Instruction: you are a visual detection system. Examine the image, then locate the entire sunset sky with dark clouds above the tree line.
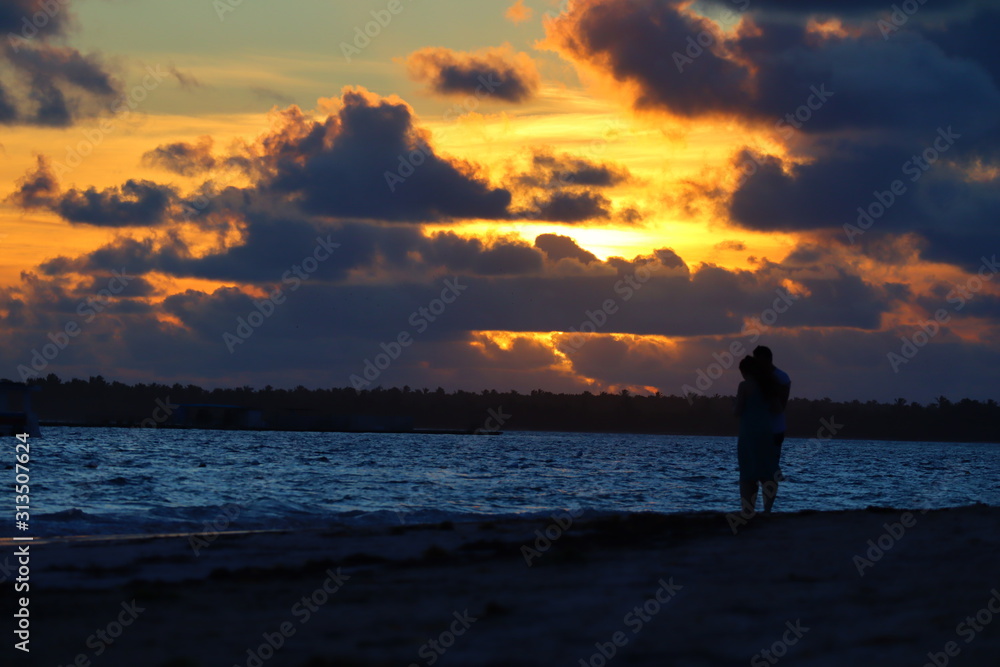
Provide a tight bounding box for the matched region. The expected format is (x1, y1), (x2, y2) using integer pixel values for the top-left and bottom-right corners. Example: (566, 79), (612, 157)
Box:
(0, 0), (1000, 402)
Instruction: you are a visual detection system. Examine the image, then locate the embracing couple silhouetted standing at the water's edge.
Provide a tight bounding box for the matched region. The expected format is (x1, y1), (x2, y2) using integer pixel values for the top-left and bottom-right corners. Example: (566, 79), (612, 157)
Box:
(735, 345), (792, 517)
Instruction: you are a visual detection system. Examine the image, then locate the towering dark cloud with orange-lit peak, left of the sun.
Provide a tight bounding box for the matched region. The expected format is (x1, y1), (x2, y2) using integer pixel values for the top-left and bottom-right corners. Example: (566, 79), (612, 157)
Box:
(28, 90), (511, 237)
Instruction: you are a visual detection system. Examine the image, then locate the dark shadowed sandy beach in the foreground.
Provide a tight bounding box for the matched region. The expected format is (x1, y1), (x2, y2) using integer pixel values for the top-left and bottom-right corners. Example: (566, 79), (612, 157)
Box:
(7, 506), (1000, 667)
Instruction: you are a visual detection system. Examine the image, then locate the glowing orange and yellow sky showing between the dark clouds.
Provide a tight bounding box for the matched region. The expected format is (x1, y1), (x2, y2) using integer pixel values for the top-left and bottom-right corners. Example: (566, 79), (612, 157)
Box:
(0, 0), (1000, 402)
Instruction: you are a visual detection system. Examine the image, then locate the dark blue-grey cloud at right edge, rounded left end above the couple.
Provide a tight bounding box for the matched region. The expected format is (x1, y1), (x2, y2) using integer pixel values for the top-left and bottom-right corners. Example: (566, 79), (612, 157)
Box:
(729, 137), (1000, 269)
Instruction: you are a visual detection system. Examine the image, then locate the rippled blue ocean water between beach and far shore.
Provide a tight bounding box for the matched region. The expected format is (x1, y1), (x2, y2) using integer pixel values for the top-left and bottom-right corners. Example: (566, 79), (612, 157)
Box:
(9, 427), (1000, 536)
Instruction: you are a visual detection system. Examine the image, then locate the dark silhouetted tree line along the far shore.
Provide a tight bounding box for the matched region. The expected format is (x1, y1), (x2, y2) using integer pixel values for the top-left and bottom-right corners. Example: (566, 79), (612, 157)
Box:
(9, 374), (1000, 442)
